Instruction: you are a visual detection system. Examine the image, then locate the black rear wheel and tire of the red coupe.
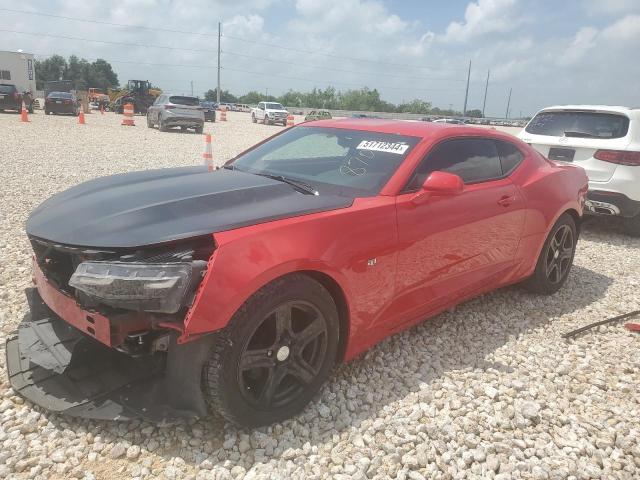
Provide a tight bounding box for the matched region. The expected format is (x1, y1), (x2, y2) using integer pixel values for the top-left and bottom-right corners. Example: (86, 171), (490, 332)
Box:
(524, 213), (578, 295)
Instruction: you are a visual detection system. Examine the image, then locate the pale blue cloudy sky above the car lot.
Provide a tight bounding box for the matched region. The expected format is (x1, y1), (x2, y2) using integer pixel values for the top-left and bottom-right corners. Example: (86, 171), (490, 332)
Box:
(0, 0), (640, 117)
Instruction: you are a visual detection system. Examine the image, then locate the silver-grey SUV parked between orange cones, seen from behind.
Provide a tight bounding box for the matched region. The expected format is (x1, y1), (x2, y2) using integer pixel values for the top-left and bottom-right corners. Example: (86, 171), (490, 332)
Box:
(147, 93), (204, 133)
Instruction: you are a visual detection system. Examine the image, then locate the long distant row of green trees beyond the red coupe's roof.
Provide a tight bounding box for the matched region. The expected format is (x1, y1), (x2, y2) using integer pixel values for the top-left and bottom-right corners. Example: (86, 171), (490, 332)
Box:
(205, 87), (482, 117)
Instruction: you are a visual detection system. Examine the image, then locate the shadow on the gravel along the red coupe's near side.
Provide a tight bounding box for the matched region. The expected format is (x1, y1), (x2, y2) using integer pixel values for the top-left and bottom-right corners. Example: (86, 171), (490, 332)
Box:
(38, 265), (613, 469)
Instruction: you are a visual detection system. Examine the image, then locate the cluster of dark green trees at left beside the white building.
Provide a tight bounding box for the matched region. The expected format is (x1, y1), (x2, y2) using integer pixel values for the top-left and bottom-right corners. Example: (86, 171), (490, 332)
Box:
(35, 55), (118, 91)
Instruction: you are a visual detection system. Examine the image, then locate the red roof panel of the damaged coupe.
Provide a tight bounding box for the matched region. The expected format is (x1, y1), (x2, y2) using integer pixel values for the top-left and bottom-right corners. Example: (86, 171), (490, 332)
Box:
(300, 117), (509, 138)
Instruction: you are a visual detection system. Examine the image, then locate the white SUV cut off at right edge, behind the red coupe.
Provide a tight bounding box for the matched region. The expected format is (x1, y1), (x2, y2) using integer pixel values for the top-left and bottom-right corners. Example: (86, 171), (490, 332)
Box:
(518, 105), (640, 236)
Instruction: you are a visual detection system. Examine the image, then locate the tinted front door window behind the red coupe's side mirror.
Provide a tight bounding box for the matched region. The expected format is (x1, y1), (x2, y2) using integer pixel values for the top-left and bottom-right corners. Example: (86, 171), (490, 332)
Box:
(404, 138), (502, 192)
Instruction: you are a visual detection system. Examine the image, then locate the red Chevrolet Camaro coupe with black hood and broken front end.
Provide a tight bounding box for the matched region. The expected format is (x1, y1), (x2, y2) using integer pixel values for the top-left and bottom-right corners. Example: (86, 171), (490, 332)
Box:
(6, 119), (587, 426)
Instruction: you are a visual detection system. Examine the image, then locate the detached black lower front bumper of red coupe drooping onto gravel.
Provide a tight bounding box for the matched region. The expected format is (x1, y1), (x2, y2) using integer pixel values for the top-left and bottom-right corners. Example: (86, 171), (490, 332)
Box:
(6, 288), (212, 424)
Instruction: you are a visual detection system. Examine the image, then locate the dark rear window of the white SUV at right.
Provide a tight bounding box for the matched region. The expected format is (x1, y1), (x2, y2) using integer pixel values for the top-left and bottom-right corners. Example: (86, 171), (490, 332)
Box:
(525, 111), (629, 138)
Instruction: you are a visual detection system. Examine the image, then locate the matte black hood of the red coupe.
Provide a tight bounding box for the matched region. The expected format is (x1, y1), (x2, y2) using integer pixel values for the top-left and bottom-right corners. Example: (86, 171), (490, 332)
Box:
(27, 167), (353, 248)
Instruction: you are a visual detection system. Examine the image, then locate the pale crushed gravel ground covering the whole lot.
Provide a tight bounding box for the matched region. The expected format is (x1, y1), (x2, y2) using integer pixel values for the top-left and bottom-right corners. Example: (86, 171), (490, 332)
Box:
(0, 112), (640, 480)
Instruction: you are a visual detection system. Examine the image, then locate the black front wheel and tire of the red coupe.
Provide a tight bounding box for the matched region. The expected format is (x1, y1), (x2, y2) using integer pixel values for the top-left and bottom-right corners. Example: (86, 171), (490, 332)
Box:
(202, 274), (340, 428)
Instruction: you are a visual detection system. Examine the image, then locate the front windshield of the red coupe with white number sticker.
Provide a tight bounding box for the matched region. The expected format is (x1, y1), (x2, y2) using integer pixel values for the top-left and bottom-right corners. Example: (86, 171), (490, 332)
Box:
(232, 127), (420, 197)
